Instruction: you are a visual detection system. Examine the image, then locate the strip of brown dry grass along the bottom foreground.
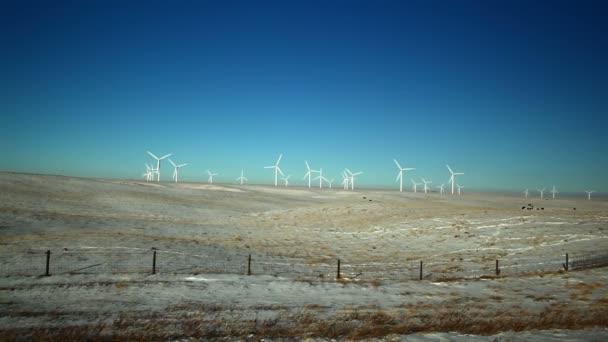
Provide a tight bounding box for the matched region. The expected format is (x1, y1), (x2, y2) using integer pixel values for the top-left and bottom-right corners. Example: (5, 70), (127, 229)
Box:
(2, 303), (608, 341)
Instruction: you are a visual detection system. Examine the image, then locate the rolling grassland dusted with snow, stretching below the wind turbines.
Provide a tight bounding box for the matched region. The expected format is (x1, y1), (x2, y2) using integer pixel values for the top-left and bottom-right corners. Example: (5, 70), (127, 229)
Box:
(0, 173), (608, 341)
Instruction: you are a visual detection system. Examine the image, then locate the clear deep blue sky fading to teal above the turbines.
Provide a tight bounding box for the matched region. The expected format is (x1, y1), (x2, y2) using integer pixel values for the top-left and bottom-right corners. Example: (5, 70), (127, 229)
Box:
(0, 0), (608, 192)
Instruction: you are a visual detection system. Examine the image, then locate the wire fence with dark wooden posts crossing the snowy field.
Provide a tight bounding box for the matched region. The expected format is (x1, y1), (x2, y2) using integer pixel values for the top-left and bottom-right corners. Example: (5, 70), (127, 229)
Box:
(0, 247), (608, 281)
